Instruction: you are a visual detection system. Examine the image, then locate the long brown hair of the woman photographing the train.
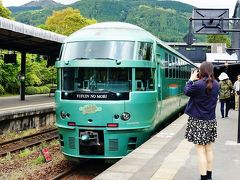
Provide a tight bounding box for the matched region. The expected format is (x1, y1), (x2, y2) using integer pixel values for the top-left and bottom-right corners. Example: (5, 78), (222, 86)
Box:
(199, 61), (215, 95)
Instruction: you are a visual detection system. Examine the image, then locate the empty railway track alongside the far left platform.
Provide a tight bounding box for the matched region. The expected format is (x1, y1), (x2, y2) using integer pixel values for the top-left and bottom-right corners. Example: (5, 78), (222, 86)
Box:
(0, 128), (58, 156)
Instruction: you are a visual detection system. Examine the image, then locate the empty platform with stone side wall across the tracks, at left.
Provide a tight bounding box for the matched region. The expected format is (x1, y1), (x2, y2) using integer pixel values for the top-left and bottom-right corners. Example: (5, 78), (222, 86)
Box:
(0, 94), (55, 135)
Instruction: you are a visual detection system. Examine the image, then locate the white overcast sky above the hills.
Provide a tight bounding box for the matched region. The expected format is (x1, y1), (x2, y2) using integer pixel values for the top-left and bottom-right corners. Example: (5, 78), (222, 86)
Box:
(3, 0), (237, 17)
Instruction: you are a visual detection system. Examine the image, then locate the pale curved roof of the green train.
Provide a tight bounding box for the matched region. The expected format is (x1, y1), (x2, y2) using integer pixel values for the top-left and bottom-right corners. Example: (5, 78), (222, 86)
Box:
(64, 22), (194, 65)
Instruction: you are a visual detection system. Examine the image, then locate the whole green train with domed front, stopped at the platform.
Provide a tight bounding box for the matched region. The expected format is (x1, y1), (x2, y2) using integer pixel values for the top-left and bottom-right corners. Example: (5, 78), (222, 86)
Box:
(55, 22), (196, 161)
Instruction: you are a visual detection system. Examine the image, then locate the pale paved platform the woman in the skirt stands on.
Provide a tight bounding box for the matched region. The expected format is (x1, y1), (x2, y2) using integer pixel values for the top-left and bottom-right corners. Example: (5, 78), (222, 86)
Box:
(94, 103), (240, 180)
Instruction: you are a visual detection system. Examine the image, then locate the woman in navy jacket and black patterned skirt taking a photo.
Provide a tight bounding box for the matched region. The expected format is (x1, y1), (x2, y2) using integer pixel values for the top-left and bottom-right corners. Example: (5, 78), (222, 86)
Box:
(184, 61), (219, 180)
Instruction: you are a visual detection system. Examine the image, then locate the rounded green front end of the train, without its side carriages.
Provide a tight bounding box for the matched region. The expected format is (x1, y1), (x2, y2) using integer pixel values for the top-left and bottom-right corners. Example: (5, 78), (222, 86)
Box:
(55, 23), (157, 160)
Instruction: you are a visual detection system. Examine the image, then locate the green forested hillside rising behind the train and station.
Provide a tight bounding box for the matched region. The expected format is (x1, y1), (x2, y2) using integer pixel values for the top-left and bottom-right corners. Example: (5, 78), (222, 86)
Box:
(9, 0), (203, 42)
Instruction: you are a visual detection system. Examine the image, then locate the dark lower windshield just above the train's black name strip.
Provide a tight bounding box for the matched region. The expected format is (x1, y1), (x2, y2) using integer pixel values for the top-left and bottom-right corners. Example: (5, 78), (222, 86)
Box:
(62, 67), (132, 92)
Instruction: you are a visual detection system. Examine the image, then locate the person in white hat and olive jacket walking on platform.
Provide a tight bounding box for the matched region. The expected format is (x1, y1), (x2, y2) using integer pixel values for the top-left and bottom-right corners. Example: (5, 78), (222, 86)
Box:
(218, 72), (233, 118)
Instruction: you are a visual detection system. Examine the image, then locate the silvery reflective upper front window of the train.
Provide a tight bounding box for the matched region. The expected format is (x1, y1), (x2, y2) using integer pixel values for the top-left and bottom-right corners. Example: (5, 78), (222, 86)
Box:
(61, 41), (134, 60)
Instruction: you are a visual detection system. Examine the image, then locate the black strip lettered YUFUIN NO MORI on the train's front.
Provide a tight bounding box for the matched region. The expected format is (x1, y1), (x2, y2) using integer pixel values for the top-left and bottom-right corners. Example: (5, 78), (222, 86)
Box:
(62, 92), (129, 101)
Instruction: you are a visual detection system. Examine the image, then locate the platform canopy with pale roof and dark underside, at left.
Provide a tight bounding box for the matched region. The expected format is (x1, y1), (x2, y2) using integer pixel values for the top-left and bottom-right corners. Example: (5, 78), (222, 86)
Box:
(0, 17), (66, 57)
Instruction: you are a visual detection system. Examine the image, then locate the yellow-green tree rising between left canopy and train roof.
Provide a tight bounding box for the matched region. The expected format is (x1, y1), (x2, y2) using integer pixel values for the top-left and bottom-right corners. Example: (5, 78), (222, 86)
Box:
(41, 7), (97, 35)
